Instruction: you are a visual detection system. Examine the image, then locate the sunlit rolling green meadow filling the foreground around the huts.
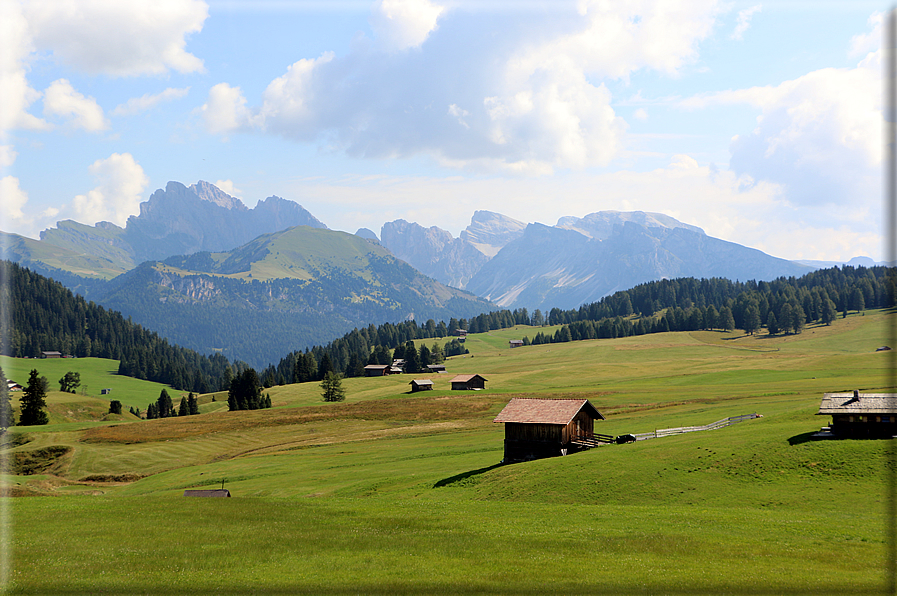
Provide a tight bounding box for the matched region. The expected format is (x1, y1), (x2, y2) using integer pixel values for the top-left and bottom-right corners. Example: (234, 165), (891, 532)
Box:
(0, 311), (897, 595)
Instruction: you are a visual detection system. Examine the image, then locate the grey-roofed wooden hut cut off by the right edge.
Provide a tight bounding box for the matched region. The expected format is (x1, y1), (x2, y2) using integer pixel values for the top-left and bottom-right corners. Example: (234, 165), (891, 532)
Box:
(817, 391), (897, 439)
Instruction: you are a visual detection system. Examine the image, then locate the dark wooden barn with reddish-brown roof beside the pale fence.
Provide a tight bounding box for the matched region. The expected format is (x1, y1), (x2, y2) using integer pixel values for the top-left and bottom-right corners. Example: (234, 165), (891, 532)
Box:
(493, 397), (604, 463)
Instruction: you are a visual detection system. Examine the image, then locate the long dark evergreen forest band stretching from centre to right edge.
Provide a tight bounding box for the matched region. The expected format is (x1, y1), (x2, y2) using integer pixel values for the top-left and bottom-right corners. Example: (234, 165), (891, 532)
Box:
(262, 266), (895, 387)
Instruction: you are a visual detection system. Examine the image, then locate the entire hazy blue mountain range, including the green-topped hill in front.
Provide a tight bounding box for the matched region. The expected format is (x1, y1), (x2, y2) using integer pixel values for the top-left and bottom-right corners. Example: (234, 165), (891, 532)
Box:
(0, 181), (872, 366)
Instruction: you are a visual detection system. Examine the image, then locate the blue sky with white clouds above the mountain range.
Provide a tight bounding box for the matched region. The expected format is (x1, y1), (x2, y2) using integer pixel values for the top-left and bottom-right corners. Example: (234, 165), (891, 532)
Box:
(0, 0), (888, 261)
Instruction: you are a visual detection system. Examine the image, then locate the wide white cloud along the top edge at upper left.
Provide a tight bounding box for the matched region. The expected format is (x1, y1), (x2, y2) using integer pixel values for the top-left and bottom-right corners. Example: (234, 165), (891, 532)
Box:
(24, 0), (209, 76)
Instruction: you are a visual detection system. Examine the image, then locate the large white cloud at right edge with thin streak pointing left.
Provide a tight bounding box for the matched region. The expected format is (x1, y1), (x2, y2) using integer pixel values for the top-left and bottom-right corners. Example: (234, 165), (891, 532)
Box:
(681, 54), (882, 210)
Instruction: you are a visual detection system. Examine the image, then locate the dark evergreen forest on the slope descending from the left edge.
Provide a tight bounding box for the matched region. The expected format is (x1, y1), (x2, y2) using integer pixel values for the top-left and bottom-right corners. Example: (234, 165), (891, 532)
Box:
(0, 261), (229, 393)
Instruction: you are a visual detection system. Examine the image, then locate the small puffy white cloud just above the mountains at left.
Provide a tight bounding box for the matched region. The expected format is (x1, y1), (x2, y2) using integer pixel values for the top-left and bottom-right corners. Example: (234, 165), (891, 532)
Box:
(71, 153), (149, 226)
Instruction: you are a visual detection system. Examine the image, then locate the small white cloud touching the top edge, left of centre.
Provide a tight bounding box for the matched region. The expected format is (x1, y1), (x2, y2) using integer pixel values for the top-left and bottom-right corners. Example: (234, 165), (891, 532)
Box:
(370, 0), (445, 51)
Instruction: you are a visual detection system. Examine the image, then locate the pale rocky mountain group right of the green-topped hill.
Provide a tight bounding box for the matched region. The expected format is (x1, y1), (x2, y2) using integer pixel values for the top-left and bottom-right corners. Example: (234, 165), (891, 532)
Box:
(381, 211), (817, 309)
